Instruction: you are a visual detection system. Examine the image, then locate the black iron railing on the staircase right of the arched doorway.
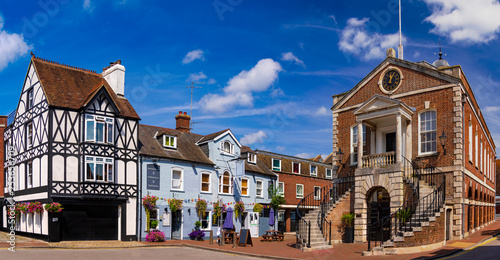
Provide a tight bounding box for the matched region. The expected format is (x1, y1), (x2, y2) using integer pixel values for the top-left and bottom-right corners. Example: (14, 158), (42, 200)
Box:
(367, 157), (446, 251)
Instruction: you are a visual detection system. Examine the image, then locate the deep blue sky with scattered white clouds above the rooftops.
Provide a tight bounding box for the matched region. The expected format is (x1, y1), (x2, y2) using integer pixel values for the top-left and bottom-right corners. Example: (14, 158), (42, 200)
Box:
(0, 0), (500, 157)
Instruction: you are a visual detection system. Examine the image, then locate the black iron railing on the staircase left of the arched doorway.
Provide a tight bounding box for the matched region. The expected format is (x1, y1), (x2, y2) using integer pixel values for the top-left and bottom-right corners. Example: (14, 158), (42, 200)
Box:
(297, 171), (354, 247)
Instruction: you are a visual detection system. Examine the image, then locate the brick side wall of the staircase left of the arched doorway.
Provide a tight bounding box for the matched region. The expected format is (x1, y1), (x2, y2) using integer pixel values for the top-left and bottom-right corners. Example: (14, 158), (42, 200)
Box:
(324, 190), (354, 242)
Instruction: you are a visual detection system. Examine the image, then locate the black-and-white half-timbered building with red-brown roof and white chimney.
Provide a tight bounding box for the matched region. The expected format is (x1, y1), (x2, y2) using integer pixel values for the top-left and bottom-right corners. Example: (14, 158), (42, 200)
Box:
(2, 55), (140, 241)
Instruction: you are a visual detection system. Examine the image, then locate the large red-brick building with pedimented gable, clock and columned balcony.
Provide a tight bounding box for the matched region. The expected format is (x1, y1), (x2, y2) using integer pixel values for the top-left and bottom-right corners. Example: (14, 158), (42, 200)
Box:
(326, 49), (496, 252)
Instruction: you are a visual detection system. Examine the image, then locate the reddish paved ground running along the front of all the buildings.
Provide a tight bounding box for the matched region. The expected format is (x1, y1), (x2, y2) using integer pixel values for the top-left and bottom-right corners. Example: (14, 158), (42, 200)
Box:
(0, 220), (500, 260)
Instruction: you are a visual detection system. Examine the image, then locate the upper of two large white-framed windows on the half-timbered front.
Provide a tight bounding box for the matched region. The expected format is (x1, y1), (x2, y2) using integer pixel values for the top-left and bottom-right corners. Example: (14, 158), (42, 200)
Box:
(85, 115), (114, 144)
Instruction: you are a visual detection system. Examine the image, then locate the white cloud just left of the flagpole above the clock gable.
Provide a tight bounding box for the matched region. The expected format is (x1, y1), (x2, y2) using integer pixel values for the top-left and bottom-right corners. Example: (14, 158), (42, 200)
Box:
(338, 17), (399, 60)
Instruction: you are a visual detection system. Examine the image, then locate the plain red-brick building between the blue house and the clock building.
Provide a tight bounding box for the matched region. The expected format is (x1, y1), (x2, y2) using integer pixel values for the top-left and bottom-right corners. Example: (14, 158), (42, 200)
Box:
(255, 150), (333, 232)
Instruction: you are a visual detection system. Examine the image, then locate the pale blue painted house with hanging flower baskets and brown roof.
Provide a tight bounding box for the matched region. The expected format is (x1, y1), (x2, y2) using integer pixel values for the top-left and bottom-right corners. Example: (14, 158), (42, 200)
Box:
(138, 113), (277, 240)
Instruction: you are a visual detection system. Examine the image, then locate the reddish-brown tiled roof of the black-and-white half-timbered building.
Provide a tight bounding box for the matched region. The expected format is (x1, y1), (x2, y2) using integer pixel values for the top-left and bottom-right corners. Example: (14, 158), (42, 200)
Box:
(31, 57), (139, 119)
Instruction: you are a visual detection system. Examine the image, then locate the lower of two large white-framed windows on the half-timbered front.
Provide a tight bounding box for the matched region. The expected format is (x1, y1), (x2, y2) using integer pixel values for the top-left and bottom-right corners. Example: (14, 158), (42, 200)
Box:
(85, 156), (115, 182)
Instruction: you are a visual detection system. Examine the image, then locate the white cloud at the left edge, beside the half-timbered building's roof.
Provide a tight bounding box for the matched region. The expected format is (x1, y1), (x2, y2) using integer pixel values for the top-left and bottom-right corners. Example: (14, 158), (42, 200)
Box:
(0, 16), (32, 71)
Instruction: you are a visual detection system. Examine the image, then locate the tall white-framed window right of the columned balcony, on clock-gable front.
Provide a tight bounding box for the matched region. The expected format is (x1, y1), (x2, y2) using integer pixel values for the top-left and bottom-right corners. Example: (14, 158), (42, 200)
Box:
(418, 110), (437, 154)
